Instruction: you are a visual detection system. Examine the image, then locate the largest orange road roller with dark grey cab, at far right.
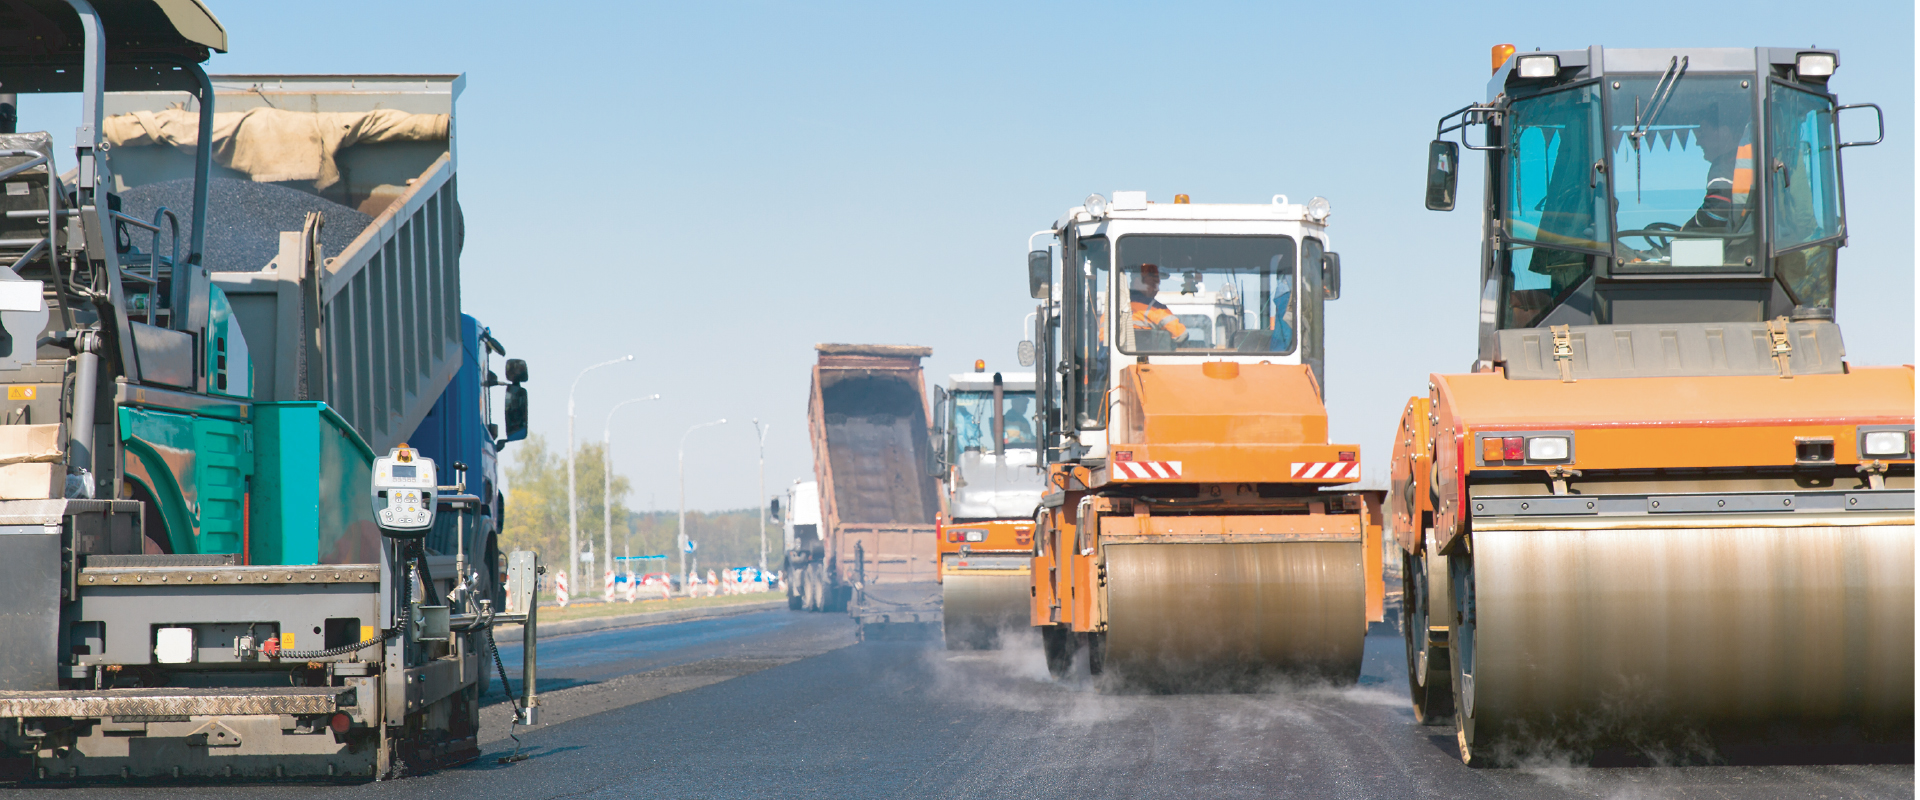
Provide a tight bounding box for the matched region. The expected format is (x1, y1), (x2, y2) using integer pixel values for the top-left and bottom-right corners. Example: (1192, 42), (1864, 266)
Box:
(1388, 46), (1914, 765)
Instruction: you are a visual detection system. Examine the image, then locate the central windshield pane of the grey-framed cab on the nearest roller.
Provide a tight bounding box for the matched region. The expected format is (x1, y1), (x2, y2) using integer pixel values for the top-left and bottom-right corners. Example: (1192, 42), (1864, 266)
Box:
(1607, 71), (1757, 271)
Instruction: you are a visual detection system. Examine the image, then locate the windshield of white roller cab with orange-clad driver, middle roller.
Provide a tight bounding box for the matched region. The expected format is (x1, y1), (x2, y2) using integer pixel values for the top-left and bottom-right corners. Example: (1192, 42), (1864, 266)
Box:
(1114, 236), (1294, 353)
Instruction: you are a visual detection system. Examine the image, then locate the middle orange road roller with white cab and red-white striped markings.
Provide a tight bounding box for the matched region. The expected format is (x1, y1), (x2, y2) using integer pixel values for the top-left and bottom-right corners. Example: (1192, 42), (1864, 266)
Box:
(1021, 192), (1382, 691)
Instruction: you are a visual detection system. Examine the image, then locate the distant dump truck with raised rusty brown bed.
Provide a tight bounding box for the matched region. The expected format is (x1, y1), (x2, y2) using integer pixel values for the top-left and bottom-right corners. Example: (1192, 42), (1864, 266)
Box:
(787, 343), (941, 637)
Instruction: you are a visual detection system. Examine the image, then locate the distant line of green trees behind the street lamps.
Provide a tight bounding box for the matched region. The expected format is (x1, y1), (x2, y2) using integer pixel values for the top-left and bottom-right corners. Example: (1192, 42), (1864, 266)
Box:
(501, 435), (781, 572)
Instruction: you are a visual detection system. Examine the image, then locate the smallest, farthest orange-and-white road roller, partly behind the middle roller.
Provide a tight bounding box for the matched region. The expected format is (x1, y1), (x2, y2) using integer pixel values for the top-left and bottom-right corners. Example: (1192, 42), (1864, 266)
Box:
(927, 361), (1044, 650)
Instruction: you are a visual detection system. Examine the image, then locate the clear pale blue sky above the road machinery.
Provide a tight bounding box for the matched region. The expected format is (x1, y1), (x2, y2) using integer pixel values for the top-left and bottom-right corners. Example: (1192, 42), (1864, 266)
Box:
(41, 0), (1914, 510)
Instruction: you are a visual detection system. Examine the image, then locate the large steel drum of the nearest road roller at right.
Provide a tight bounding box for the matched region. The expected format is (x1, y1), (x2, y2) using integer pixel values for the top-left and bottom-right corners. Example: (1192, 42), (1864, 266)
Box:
(1455, 522), (1914, 758)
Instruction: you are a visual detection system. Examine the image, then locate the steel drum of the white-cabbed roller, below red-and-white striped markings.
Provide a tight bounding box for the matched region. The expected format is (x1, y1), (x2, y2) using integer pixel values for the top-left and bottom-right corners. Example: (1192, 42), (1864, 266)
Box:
(1106, 541), (1367, 689)
